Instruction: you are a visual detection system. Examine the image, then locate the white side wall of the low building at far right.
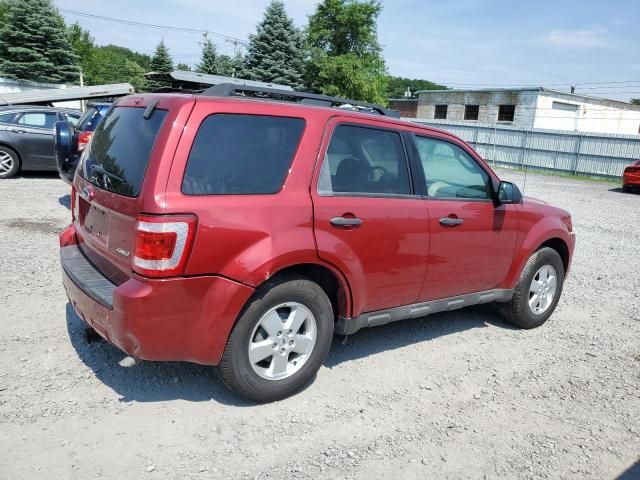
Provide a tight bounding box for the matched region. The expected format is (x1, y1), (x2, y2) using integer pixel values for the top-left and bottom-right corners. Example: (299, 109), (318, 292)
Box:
(533, 92), (640, 135)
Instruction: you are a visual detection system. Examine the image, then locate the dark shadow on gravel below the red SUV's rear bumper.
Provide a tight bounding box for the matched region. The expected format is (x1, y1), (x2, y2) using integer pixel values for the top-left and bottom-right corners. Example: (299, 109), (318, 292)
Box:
(66, 303), (253, 407)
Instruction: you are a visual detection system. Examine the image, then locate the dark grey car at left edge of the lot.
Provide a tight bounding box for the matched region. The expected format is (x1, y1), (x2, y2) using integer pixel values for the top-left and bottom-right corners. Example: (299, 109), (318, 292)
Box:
(0, 105), (81, 179)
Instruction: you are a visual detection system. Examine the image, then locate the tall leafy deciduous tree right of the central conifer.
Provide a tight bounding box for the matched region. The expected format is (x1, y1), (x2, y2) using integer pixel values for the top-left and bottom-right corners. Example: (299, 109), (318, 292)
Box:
(305, 0), (388, 103)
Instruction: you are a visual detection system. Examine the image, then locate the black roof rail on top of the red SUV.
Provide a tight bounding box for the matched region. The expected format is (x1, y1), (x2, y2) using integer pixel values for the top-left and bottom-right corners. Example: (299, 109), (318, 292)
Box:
(201, 83), (400, 118)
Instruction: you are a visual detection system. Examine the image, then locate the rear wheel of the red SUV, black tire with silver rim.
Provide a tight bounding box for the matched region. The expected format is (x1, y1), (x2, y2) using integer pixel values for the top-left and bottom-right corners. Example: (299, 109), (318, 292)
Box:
(218, 275), (334, 403)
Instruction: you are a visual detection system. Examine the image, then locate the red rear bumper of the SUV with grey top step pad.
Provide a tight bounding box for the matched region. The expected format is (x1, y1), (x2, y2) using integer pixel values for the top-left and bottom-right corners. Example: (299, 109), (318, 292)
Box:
(60, 234), (254, 365)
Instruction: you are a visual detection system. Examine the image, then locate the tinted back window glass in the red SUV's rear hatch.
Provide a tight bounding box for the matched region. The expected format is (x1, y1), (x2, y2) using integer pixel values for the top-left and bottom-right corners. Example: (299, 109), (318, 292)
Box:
(81, 107), (167, 197)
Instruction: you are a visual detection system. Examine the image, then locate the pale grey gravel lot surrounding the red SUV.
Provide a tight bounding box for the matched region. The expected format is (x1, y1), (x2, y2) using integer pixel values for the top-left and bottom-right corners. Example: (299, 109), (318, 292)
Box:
(0, 172), (640, 479)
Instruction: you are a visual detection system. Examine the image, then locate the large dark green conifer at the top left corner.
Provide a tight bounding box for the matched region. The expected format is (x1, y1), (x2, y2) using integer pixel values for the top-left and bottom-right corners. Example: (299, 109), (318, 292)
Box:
(0, 0), (79, 83)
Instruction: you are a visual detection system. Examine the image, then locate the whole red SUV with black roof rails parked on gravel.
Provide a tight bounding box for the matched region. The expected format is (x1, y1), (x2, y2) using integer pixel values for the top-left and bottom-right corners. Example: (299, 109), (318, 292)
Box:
(60, 84), (575, 402)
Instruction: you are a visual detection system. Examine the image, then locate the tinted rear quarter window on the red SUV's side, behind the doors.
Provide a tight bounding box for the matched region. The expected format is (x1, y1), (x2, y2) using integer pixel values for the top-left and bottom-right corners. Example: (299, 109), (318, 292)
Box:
(182, 114), (304, 195)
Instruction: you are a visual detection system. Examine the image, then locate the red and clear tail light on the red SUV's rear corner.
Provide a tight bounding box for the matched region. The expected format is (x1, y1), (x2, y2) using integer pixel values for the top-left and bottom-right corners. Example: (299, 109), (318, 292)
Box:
(133, 215), (196, 277)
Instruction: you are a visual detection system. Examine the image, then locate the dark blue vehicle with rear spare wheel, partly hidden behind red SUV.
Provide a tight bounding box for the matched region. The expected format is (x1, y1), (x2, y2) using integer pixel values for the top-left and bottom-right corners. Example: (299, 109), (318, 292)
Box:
(55, 103), (111, 185)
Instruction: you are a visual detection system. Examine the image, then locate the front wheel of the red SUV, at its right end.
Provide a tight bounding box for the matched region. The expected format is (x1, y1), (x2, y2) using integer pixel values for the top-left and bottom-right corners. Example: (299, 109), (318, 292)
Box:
(500, 247), (564, 329)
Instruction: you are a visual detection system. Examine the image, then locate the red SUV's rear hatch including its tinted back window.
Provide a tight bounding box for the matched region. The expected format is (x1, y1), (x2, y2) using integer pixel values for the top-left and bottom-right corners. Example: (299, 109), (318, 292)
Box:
(72, 95), (194, 284)
